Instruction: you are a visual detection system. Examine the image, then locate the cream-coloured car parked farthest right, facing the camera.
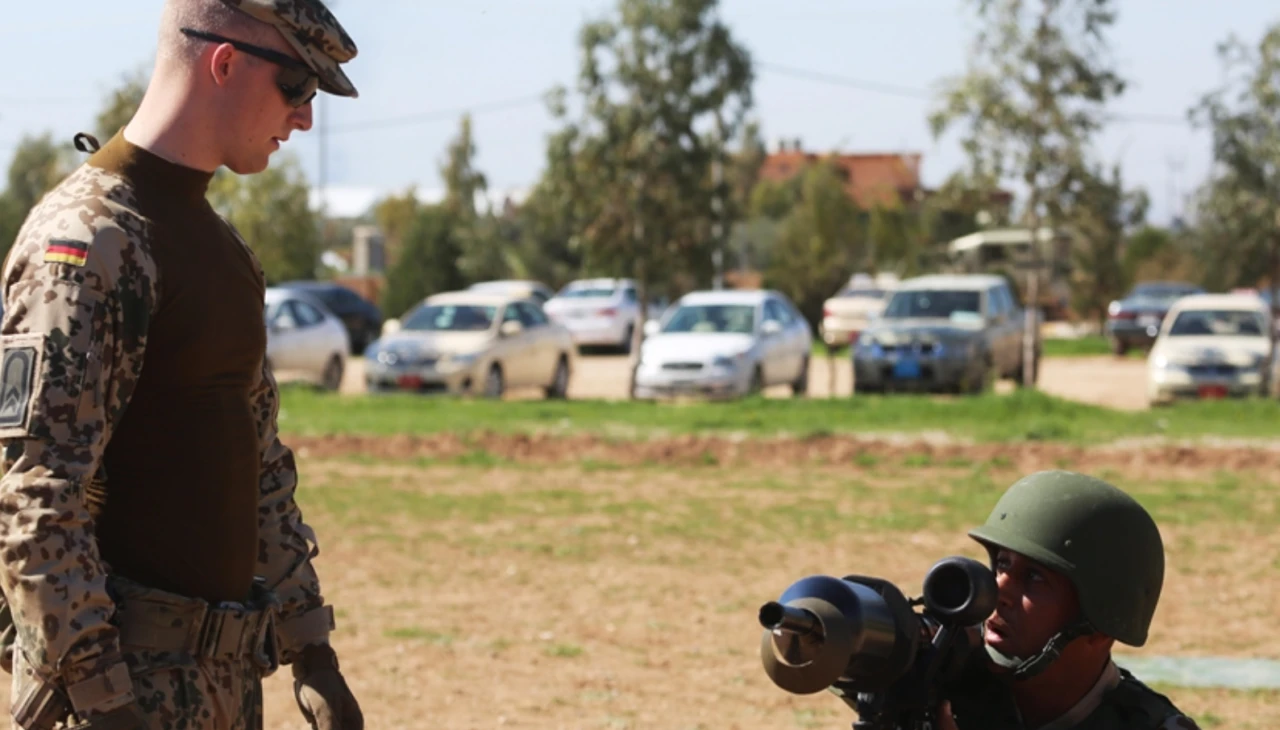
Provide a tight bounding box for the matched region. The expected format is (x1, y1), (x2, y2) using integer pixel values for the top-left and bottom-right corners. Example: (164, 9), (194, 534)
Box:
(1147, 289), (1276, 405)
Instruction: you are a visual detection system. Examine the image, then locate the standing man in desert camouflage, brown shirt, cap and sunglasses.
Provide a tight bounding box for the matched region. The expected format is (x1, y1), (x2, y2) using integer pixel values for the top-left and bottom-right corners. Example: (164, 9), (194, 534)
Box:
(0, 0), (364, 730)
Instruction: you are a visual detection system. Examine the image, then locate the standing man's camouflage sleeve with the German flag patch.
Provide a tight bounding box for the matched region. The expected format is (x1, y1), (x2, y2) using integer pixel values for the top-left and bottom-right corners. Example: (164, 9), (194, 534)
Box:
(0, 220), (157, 710)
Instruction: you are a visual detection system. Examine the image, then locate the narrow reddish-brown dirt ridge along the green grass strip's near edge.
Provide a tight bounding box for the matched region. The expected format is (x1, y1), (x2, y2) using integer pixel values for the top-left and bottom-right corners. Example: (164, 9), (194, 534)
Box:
(287, 433), (1280, 475)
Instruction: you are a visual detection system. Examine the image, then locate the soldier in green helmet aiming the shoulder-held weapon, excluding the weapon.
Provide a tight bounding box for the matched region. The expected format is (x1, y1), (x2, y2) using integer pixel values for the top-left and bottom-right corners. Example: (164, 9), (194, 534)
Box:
(940, 471), (1197, 730)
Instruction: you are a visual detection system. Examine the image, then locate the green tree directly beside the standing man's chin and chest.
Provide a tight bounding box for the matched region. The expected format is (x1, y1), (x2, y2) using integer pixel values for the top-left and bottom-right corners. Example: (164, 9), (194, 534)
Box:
(209, 154), (320, 286)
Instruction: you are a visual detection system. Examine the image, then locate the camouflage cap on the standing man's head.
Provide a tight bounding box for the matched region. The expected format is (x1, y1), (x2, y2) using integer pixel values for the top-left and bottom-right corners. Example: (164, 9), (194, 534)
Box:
(223, 0), (360, 97)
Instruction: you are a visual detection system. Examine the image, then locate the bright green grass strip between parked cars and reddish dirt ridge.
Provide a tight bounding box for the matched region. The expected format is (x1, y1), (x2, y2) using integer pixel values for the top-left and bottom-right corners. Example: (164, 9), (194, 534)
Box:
(280, 389), (1280, 440)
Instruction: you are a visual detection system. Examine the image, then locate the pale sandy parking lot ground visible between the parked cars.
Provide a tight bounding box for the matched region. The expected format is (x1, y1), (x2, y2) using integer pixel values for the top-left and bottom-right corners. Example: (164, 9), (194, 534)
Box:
(342, 355), (1147, 410)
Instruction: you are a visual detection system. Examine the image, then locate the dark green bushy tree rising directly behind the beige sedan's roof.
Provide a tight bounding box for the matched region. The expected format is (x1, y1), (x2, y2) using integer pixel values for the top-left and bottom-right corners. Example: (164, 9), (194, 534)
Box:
(381, 205), (463, 316)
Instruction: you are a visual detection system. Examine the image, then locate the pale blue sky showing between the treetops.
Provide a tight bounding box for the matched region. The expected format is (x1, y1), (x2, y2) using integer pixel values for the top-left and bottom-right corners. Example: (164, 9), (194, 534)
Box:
(0, 0), (1280, 223)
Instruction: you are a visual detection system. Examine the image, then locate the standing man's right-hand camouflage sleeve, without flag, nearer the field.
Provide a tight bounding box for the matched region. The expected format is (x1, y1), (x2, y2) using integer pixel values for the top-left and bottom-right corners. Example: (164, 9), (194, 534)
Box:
(253, 361), (333, 663)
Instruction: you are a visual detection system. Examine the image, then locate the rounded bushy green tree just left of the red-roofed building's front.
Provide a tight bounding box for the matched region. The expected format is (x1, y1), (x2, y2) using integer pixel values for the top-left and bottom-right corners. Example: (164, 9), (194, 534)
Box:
(765, 160), (867, 327)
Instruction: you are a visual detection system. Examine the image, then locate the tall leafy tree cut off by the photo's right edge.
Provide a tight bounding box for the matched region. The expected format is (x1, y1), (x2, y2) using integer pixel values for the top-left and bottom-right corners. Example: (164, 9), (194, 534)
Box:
(1190, 24), (1280, 345)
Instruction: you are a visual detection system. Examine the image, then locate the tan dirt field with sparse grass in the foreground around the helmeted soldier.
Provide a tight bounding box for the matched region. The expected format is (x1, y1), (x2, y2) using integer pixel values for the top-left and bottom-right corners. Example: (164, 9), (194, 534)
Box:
(0, 435), (1280, 730)
